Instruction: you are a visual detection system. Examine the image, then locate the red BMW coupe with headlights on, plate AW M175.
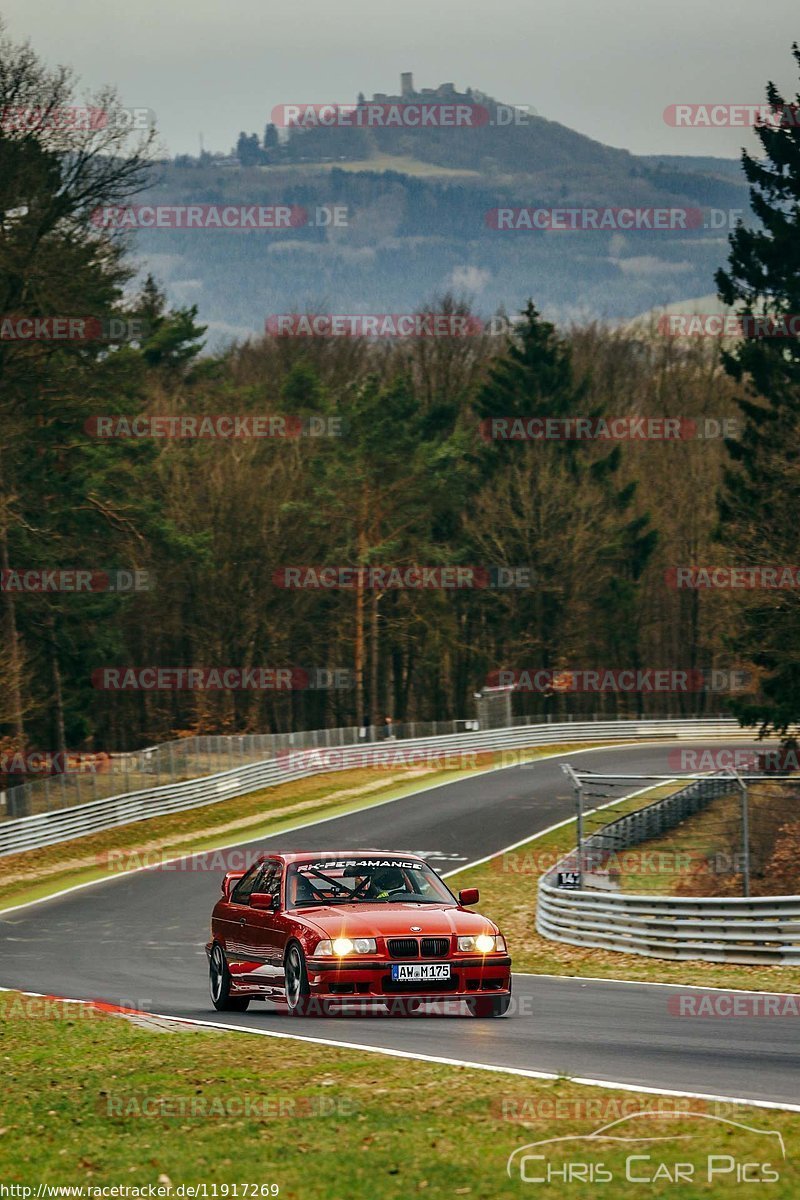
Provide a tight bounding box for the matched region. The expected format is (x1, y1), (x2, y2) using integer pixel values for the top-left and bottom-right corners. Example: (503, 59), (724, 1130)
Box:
(206, 850), (511, 1016)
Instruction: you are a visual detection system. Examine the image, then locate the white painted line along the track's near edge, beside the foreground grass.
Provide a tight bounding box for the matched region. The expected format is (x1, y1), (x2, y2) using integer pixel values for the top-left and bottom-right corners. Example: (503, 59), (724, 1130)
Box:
(0, 988), (800, 1112)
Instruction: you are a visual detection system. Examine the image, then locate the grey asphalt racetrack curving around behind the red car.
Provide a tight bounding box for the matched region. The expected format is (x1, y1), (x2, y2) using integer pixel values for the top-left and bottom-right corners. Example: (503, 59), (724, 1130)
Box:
(0, 740), (800, 1104)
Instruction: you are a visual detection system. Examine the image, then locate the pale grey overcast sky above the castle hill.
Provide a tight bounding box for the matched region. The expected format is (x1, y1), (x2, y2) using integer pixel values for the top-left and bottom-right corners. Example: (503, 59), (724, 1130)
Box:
(2, 0), (800, 157)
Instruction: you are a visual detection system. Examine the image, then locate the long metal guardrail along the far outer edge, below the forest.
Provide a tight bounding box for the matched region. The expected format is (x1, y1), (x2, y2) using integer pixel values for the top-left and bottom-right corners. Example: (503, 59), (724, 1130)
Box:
(0, 718), (753, 856)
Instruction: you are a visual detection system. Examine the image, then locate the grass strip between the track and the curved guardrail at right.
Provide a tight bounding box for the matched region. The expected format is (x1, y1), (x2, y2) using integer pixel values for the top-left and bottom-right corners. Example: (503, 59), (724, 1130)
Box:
(449, 787), (800, 992)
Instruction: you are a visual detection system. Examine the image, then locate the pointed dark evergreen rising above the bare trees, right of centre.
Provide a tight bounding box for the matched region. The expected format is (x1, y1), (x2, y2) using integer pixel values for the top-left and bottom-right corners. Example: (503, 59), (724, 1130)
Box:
(475, 302), (657, 705)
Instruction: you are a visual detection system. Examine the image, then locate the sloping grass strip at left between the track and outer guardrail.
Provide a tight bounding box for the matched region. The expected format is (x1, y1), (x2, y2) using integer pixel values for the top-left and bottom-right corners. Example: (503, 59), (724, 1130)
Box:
(0, 743), (599, 911)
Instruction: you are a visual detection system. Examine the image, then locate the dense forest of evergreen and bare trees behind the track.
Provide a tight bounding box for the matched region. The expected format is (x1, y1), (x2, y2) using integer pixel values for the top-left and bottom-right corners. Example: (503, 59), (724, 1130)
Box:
(0, 25), (800, 768)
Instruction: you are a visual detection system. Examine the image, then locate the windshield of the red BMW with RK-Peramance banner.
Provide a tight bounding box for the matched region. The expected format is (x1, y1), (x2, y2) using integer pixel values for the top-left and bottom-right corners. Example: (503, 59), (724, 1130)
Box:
(287, 858), (456, 908)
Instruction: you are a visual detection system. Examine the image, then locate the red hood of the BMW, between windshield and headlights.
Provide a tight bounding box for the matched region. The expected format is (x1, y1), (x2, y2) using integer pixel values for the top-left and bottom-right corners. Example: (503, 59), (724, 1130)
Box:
(293, 904), (499, 937)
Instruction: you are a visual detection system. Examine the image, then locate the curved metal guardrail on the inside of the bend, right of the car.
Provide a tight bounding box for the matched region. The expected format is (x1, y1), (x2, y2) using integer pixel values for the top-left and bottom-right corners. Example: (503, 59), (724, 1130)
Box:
(536, 776), (800, 965)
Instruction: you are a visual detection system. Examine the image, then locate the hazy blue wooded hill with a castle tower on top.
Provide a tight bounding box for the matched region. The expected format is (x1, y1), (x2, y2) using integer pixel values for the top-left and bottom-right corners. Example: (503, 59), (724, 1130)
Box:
(134, 77), (748, 342)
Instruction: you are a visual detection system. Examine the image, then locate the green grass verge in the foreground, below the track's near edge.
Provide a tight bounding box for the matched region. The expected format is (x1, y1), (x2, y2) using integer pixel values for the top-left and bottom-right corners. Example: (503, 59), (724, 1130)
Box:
(0, 992), (800, 1200)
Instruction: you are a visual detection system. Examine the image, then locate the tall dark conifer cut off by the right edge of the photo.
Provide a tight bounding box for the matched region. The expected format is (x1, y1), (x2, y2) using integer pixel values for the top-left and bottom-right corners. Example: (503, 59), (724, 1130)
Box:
(716, 43), (800, 733)
